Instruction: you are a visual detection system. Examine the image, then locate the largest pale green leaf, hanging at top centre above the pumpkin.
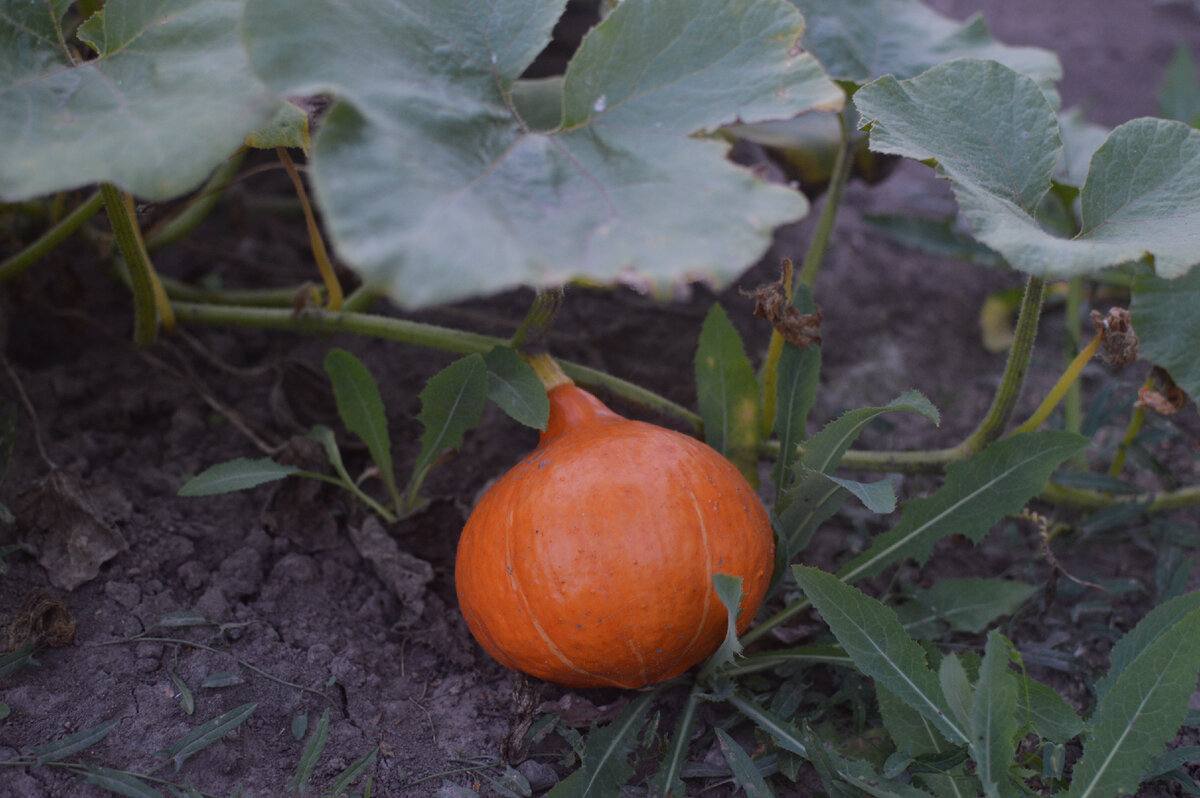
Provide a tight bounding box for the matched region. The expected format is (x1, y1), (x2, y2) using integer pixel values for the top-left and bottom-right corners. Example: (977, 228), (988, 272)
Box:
(245, 0), (844, 306)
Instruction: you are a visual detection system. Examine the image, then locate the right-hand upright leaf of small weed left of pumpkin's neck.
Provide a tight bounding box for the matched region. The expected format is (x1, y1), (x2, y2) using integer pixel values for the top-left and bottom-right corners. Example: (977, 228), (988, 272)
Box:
(402, 354), (487, 511)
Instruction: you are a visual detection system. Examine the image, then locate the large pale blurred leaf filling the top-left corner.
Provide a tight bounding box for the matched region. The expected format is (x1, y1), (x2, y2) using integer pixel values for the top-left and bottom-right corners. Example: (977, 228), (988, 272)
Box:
(0, 0), (276, 199)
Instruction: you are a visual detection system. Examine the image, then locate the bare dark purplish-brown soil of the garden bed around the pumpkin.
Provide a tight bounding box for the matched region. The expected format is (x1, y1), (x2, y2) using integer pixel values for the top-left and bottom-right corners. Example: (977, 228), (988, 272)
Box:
(0, 0), (1200, 798)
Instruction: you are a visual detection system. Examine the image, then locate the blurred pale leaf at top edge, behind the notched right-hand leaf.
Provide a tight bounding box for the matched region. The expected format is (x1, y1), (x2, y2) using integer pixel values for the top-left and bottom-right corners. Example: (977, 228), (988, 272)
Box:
(792, 0), (1062, 90)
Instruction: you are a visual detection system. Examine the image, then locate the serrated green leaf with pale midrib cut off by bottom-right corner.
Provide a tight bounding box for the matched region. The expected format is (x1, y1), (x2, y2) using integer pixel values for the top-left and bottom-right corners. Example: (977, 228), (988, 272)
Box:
(1066, 610), (1200, 798)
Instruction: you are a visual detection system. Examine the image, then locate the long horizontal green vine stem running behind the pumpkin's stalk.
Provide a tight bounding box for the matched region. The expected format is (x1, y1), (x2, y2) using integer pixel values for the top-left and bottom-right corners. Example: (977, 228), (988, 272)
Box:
(174, 302), (701, 432)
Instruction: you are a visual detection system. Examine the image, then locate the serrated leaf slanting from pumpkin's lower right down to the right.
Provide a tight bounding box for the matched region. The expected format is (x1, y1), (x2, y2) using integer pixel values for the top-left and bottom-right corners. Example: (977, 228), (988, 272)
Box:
(792, 565), (970, 744)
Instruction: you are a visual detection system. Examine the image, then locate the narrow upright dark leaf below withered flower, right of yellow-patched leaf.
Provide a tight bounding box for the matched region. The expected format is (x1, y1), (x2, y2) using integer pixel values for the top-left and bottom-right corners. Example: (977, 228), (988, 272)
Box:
(770, 283), (821, 499)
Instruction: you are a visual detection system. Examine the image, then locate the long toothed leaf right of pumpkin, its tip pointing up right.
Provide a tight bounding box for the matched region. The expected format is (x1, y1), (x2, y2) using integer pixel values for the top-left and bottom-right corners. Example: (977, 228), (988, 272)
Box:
(839, 430), (1088, 582)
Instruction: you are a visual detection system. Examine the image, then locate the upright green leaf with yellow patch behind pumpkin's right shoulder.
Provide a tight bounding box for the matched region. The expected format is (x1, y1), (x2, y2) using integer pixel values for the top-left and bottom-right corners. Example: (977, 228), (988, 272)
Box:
(695, 305), (760, 485)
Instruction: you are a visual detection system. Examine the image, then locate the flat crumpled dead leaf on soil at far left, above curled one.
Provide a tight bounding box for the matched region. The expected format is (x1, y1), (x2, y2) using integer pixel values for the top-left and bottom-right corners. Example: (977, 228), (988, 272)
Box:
(13, 469), (127, 592)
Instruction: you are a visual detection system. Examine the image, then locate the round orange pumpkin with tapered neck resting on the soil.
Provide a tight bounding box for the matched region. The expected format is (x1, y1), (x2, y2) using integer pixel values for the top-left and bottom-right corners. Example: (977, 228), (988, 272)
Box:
(455, 385), (774, 688)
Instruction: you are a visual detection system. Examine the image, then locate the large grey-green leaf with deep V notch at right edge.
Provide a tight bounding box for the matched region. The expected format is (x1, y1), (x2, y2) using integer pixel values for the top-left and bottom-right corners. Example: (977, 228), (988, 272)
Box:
(854, 59), (1200, 278)
